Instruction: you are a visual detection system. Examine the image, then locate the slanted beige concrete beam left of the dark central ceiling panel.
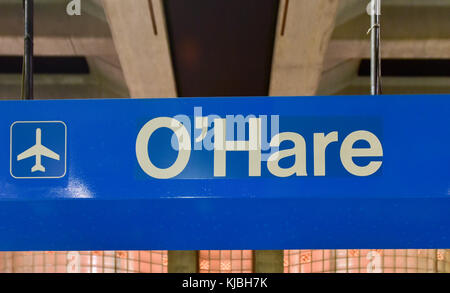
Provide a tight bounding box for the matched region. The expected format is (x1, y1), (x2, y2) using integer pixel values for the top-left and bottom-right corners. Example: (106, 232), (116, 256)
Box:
(103, 0), (177, 98)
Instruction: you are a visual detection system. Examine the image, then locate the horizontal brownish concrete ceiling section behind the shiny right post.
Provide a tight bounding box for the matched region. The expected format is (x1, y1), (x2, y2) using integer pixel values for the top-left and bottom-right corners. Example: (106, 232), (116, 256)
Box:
(327, 5), (450, 61)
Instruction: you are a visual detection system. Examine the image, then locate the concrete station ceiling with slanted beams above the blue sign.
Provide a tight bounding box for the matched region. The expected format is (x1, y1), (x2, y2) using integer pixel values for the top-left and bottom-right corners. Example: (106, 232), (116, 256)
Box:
(0, 0), (450, 99)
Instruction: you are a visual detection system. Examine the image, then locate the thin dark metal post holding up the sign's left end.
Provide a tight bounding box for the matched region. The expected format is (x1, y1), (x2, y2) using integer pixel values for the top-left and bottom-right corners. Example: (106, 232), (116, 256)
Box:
(22, 0), (34, 100)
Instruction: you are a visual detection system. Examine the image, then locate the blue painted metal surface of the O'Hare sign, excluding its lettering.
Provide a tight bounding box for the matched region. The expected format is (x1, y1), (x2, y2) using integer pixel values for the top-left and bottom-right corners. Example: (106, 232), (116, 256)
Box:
(0, 95), (450, 250)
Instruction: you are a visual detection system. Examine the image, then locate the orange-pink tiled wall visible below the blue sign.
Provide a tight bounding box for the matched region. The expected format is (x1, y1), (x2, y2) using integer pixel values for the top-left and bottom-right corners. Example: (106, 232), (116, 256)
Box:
(0, 249), (450, 273)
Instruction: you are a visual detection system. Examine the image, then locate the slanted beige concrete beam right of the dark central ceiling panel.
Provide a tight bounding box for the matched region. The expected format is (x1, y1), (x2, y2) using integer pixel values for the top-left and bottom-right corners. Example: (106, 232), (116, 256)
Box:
(269, 0), (339, 96)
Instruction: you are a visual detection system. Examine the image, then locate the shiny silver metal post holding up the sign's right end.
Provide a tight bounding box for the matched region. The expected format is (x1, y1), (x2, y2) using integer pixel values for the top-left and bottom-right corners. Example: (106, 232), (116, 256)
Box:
(369, 0), (381, 95)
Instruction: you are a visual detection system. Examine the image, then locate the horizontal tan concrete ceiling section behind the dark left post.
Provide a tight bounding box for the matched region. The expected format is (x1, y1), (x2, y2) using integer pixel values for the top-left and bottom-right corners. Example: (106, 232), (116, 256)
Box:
(0, 1), (116, 56)
